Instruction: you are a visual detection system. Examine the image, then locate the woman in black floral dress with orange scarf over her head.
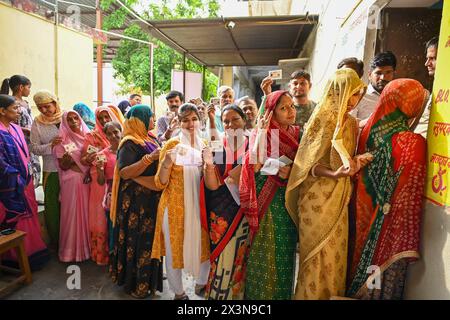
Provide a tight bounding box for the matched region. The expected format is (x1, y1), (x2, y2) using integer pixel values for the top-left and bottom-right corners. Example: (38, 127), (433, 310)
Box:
(107, 105), (163, 298)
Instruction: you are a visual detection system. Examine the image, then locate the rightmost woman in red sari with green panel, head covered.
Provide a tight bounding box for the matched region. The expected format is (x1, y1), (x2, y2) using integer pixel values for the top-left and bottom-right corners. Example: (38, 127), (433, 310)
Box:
(347, 79), (426, 299)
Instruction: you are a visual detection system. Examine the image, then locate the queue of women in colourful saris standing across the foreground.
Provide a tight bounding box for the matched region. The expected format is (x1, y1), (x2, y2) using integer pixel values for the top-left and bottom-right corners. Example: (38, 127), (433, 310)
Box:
(0, 68), (426, 300)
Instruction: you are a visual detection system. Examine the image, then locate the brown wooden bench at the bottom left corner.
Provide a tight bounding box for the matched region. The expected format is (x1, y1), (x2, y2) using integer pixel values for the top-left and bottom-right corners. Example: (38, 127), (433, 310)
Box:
(0, 230), (32, 297)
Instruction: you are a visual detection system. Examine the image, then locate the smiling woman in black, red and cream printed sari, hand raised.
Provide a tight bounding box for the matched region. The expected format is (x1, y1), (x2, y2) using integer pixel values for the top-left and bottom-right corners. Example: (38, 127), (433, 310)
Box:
(200, 105), (248, 300)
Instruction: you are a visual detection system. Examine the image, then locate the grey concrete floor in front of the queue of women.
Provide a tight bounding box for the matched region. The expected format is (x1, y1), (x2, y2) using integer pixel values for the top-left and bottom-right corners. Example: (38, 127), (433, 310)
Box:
(0, 187), (203, 300)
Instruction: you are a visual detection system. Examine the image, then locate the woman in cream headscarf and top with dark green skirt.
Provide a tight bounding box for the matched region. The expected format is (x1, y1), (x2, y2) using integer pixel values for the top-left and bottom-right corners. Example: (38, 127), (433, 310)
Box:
(30, 90), (62, 249)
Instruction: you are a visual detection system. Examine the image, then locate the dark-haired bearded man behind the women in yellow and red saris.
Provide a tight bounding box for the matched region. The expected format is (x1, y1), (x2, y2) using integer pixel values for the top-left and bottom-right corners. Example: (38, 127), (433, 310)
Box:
(350, 51), (397, 128)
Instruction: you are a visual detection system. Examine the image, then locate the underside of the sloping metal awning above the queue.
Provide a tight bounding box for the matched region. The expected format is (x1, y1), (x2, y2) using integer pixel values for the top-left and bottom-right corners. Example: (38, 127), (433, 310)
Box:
(141, 15), (318, 67)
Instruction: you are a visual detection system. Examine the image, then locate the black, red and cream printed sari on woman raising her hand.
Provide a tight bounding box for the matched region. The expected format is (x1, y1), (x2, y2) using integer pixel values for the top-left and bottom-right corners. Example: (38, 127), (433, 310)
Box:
(201, 139), (249, 300)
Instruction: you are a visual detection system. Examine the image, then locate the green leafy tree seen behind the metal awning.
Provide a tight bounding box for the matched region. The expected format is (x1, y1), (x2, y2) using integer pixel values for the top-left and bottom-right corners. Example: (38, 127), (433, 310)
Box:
(101, 0), (219, 100)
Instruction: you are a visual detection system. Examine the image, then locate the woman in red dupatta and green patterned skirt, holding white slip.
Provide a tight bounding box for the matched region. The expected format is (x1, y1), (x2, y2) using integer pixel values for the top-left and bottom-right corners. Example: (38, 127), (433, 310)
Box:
(239, 90), (299, 300)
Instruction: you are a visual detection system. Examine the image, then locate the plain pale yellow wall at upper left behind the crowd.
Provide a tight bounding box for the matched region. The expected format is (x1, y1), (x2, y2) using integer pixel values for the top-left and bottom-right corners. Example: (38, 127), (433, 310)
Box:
(0, 2), (93, 114)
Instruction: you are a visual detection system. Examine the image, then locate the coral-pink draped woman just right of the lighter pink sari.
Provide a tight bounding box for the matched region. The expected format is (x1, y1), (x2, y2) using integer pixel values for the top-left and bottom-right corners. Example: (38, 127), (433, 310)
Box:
(81, 107), (118, 265)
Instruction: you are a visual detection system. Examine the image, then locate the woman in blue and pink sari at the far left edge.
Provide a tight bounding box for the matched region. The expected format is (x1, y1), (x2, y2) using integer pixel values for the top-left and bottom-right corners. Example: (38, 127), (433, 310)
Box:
(0, 94), (49, 270)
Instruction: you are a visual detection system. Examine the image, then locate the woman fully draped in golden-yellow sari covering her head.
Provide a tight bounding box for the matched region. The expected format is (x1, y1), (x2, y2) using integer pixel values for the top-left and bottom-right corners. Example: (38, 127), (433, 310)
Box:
(286, 69), (368, 300)
